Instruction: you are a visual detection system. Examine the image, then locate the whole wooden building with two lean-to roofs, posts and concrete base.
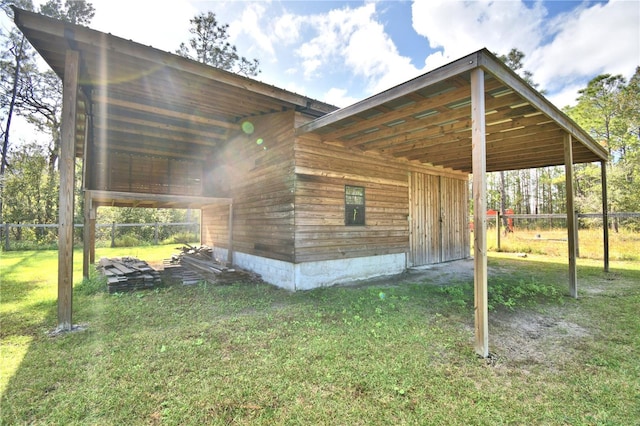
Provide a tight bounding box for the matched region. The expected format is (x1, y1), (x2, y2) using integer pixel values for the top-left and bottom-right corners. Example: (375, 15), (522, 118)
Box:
(15, 9), (607, 356)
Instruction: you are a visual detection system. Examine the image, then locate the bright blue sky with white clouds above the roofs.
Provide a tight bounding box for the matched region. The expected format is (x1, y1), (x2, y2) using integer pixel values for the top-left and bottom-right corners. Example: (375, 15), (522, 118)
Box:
(3, 0), (640, 143)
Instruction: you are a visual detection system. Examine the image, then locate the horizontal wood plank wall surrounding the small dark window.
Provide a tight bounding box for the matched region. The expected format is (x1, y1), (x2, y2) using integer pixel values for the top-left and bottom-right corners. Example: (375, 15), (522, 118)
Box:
(295, 136), (408, 262)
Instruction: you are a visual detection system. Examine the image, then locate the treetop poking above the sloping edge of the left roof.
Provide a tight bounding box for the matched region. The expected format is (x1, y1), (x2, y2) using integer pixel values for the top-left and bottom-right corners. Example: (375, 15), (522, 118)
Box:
(176, 12), (260, 77)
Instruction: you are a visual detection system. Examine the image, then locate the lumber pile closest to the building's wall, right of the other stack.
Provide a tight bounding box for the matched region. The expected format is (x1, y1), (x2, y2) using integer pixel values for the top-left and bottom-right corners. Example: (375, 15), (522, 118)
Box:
(164, 244), (260, 285)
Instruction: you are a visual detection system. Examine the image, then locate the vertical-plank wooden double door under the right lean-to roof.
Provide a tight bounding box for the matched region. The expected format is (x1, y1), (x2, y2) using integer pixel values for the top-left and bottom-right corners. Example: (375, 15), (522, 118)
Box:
(409, 172), (469, 266)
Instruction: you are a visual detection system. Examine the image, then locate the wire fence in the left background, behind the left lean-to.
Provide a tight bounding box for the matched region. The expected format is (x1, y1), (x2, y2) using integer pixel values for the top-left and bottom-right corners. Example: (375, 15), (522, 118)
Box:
(0, 222), (200, 251)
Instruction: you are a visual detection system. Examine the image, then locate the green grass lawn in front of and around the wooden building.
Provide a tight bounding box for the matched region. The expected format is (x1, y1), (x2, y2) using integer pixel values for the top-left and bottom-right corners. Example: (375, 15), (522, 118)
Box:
(0, 246), (640, 425)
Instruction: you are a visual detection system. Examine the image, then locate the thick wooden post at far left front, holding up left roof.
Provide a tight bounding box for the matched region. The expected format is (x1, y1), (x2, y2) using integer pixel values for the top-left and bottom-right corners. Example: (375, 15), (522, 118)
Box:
(58, 50), (79, 331)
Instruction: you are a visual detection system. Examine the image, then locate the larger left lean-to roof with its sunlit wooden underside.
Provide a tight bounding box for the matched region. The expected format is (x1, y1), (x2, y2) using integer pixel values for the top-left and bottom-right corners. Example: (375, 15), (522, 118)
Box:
(14, 8), (337, 160)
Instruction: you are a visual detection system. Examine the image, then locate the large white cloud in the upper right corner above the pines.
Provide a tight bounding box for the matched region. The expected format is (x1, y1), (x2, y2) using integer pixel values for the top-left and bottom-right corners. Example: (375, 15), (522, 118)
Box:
(528, 1), (640, 90)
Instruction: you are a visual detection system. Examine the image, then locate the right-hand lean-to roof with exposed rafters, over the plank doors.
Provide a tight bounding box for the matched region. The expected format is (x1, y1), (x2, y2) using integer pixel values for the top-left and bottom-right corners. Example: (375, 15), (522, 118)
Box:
(296, 49), (607, 173)
